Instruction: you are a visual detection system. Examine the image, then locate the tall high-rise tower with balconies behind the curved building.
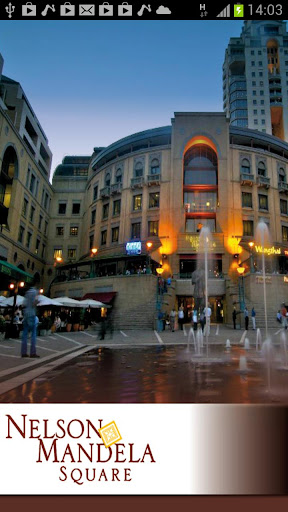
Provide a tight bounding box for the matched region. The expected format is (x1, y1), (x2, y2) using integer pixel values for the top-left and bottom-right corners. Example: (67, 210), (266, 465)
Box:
(223, 20), (288, 141)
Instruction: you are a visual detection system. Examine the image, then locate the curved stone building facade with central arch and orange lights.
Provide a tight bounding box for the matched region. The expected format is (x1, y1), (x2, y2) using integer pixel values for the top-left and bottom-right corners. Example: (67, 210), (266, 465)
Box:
(46, 112), (288, 327)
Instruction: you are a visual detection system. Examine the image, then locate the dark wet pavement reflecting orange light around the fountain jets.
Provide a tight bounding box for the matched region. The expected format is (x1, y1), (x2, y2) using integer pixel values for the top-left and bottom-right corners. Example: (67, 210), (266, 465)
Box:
(0, 340), (288, 404)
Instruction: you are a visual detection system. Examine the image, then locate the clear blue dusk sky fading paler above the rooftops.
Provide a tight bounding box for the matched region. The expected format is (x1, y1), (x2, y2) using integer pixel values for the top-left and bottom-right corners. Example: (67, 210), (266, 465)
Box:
(0, 20), (252, 172)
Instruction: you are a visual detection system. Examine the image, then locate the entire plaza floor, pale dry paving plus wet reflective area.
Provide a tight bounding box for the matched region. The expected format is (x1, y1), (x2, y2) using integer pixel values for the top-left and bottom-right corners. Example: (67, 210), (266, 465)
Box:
(0, 322), (288, 403)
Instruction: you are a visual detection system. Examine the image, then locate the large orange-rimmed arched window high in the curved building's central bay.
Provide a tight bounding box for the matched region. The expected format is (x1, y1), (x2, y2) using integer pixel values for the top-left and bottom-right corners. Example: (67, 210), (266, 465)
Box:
(184, 144), (217, 185)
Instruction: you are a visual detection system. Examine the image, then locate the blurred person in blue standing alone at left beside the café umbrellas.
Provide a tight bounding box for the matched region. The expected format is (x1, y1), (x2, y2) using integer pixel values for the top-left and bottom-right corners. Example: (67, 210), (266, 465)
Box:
(21, 278), (40, 358)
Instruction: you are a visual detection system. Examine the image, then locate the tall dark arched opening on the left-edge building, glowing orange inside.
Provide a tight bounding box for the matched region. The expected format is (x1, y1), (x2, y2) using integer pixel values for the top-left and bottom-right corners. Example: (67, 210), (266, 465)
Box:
(0, 146), (18, 225)
